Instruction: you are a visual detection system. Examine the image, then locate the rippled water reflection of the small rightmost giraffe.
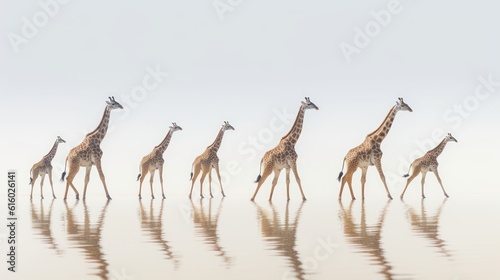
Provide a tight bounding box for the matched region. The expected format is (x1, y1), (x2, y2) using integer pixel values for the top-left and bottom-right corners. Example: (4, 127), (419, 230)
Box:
(403, 198), (451, 257)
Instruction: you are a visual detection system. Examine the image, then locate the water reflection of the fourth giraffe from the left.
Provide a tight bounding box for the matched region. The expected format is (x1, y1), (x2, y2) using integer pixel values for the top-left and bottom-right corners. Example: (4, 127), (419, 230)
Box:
(190, 198), (232, 268)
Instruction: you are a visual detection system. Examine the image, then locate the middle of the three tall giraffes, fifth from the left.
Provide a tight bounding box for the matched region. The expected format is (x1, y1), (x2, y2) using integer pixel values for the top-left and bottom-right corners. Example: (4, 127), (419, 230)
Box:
(250, 97), (319, 201)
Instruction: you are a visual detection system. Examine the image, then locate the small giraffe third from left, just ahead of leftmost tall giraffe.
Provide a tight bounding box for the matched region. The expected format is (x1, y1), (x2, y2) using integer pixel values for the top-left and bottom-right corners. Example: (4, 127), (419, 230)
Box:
(137, 123), (182, 199)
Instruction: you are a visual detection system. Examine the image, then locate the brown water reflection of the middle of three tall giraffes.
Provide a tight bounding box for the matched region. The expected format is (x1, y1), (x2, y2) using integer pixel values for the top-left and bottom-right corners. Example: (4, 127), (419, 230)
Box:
(254, 201), (306, 280)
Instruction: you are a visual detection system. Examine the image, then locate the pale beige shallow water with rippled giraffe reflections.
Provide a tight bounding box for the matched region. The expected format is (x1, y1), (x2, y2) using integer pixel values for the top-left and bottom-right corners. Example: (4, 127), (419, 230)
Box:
(0, 192), (500, 280)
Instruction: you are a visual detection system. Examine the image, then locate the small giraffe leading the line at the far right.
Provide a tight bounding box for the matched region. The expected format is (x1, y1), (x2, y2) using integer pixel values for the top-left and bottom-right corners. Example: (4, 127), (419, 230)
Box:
(401, 133), (458, 199)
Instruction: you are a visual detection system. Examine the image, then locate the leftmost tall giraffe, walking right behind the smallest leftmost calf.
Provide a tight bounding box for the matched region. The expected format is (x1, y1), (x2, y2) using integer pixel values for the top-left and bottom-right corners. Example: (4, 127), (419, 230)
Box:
(61, 97), (123, 200)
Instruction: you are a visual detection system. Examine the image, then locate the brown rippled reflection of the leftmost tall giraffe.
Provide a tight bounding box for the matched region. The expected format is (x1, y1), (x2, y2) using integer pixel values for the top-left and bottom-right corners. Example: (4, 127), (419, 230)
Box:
(64, 200), (109, 280)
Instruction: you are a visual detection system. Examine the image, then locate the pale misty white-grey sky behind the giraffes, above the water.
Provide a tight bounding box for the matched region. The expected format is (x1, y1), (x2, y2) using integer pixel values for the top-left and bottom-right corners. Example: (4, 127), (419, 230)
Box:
(0, 0), (500, 201)
